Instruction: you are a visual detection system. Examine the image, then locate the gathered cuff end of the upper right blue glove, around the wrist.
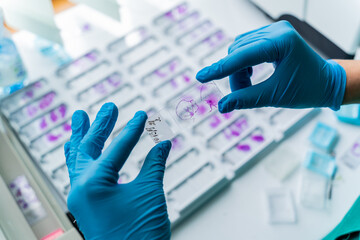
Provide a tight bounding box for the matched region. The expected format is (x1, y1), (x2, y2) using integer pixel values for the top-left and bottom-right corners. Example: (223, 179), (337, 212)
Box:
(323, 59), (346, 111)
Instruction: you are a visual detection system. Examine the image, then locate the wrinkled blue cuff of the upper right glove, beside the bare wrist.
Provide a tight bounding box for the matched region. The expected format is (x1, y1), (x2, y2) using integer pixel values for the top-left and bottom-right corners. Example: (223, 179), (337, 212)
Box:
(326, 60), (346, 111)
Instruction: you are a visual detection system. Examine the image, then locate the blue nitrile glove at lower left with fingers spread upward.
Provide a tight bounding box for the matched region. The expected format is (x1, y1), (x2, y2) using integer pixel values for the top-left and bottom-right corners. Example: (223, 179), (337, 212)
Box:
(65, 103), (171, 240)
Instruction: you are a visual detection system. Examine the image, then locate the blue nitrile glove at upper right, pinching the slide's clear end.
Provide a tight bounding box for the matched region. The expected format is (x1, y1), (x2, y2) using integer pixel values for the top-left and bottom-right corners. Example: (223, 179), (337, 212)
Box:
(196, 21), (346, 113)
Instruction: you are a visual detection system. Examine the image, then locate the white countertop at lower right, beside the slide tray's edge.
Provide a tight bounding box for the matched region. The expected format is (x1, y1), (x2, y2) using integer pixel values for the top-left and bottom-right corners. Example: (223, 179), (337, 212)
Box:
(173, 109), (360, 240)
